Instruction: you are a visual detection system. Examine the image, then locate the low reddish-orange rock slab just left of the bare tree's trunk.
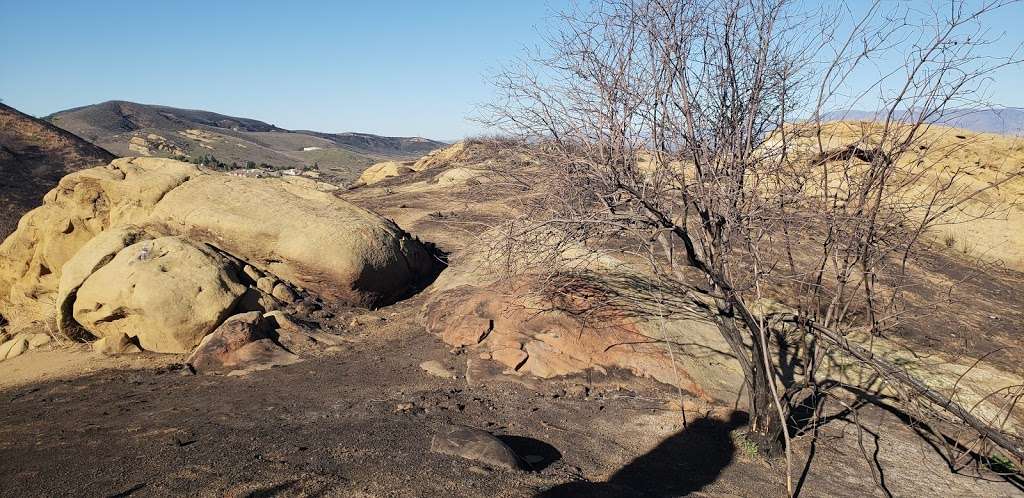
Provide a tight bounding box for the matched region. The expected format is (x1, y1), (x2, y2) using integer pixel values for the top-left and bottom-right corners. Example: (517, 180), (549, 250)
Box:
(423, 269), (742, 401)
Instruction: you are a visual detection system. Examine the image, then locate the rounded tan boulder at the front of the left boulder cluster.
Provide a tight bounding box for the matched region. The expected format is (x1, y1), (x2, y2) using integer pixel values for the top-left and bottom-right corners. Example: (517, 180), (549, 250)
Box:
(73, 237), (246, 352)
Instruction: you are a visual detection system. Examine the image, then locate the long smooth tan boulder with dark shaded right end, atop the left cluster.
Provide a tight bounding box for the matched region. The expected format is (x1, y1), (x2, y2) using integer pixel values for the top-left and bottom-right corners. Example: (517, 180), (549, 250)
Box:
(153, 175), (434, 306)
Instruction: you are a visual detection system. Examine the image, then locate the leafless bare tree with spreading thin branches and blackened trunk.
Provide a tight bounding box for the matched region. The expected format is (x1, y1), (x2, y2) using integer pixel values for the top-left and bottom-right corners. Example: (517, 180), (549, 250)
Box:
(485, 0), (1024, 492)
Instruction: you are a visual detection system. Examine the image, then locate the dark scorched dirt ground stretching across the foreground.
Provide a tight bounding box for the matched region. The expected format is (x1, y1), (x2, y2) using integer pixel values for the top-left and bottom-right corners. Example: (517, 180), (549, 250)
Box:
(0, 288), (1020, 497)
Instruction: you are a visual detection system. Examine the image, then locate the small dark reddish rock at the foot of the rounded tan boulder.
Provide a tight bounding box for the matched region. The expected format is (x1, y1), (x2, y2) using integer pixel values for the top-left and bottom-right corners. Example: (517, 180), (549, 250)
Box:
(187, 312), (299, 373)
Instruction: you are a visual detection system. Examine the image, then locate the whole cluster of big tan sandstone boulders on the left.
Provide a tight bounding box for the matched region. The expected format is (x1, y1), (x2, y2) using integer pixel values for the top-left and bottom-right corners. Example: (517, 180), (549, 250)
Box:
(0, 158), (435, 364)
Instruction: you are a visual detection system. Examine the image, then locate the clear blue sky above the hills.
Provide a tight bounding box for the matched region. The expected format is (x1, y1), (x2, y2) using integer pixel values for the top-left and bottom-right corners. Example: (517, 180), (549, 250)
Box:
(0, 0), (1024, 139)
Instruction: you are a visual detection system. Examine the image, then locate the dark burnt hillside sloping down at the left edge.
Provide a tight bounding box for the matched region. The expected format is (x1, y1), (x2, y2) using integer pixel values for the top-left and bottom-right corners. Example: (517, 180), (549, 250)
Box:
(0, 103), (115, 239)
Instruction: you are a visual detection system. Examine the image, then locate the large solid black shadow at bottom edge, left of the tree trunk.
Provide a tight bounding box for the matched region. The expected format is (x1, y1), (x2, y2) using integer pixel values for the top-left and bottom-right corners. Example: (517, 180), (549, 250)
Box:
(537, 412), (748, 498)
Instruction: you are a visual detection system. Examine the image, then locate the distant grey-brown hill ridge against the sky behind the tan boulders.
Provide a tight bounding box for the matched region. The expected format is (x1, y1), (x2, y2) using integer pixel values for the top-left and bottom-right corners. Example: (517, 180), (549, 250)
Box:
(44, 100), (445, 182)
